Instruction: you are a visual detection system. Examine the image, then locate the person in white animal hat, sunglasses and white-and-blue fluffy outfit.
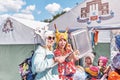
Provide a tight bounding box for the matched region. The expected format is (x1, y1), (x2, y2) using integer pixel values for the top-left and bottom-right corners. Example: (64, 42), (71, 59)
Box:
(32, 29), (65, 80)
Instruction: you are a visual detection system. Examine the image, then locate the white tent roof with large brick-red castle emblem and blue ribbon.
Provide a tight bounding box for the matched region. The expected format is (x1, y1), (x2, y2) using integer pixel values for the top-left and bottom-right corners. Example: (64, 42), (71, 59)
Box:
(48, 0), (120, 30)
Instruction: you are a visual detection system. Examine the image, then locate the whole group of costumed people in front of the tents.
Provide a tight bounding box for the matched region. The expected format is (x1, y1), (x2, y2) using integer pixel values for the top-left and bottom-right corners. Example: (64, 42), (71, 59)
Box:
(32, 26), (120, 80)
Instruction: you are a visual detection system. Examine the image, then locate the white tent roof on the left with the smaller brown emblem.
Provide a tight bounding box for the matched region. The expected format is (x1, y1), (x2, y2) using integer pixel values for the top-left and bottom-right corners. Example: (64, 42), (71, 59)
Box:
(0, 16), (48, 44)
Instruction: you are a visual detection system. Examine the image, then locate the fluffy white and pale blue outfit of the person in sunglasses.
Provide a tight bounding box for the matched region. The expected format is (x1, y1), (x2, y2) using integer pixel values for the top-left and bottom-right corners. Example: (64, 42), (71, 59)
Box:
(32, 46), (59, 80)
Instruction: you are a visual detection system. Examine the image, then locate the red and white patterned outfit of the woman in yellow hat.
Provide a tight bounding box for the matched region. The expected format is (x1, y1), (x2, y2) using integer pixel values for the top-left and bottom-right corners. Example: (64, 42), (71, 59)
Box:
(54, 49), (76, 80)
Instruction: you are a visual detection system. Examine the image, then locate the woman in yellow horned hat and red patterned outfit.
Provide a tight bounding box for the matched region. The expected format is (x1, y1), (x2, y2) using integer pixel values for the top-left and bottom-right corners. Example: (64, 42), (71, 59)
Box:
(54, 26), (79, 80)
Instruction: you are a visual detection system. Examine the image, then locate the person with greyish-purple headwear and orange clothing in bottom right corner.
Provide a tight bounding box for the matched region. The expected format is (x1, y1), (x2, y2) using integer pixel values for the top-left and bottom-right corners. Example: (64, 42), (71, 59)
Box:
(108, 53), (120, 80)
